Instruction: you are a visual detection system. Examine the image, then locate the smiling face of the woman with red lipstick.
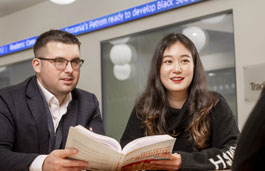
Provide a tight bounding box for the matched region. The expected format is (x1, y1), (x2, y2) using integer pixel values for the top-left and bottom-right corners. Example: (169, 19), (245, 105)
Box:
(160, 41), (194, 97)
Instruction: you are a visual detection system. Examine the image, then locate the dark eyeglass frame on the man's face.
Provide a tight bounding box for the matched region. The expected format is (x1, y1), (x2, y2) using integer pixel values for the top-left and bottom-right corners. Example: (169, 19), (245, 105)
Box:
(35, 57), (85, 70)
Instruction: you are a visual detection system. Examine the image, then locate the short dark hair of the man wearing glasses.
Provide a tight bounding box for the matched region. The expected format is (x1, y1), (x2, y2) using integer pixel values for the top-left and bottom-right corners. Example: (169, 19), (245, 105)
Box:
(33, 30), (81, 56)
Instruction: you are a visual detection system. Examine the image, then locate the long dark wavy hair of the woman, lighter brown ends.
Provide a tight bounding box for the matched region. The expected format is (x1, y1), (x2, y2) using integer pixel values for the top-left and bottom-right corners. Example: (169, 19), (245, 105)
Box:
(136, 33), (218, 150)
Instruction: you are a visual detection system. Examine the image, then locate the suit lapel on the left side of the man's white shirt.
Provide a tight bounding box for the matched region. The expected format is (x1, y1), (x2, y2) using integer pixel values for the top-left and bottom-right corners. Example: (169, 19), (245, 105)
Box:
(26, 77), (49, 154)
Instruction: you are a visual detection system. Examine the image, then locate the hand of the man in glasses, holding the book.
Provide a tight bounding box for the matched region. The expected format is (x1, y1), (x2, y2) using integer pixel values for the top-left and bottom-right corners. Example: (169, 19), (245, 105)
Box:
(42, 149), (88, 171)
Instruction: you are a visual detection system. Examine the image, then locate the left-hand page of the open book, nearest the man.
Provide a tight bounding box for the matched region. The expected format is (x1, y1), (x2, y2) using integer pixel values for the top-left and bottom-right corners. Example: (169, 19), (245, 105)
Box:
(65, 127), (123, 171)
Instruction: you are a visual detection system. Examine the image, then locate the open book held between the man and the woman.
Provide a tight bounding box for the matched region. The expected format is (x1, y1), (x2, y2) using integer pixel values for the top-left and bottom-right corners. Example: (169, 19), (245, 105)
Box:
(65, 125), (176, 171)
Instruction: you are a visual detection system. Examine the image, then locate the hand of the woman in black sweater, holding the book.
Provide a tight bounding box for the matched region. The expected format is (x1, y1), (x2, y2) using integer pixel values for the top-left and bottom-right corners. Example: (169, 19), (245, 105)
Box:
(150, 153), (182, 170)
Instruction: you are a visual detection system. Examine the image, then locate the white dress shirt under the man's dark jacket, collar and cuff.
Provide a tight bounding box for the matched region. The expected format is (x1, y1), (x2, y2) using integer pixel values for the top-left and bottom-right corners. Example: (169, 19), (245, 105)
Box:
(29, 80), (72, 171)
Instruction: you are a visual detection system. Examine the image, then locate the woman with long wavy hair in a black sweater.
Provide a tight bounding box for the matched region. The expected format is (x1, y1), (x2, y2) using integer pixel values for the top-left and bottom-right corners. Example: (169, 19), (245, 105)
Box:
(118, 33), (239, 170)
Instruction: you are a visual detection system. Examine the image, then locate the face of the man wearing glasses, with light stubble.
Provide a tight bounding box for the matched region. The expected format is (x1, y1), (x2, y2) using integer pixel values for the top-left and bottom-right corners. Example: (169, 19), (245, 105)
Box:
(33, 41), (80, 98)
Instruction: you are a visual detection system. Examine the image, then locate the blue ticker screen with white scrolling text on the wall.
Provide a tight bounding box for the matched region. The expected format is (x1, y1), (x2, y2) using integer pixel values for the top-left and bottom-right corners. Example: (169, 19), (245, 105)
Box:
(0, 0), (203, 56)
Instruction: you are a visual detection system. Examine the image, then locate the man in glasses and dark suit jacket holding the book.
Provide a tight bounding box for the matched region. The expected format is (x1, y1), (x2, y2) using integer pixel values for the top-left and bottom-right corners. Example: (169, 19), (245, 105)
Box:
(0, 30), (104, 171)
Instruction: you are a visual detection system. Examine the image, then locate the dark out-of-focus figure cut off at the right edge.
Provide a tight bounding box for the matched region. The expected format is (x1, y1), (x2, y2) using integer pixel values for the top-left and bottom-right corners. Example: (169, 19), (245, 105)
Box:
(232, 89), (265, 171)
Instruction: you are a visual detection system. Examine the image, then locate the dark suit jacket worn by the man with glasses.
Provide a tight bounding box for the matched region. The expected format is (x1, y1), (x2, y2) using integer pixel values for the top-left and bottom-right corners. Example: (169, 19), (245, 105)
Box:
(0, 76), (104, 171)
